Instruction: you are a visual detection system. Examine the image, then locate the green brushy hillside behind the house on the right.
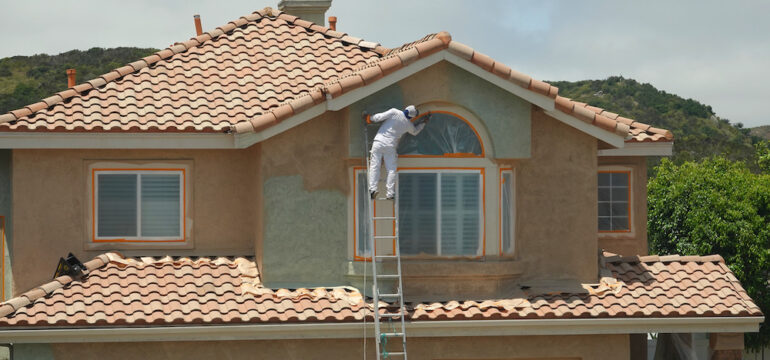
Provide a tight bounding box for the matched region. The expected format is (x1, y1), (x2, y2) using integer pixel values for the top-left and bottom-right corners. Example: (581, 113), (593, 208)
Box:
(550, 76), (758, 165)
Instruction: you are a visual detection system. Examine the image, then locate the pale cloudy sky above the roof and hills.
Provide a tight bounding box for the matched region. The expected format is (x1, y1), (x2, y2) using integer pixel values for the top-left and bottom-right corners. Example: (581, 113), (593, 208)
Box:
(0, 0), (770, 127)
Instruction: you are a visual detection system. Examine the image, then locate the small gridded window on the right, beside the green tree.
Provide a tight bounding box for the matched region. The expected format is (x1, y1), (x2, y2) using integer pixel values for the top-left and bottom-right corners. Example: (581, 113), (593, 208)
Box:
(598, 171), (631, 232)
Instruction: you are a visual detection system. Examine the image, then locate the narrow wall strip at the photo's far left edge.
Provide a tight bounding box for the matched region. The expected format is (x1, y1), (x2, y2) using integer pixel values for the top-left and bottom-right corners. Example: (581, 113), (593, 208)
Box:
(0, 149), (13, 301)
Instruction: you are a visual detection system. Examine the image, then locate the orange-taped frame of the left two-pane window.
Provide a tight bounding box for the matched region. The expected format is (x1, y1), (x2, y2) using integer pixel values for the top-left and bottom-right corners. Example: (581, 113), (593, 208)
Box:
(91, 167), (187, 244)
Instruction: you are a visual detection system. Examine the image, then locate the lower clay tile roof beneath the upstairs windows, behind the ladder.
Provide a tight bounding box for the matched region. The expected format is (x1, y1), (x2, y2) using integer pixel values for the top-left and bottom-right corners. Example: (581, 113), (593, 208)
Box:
(0, 253), (762, 331)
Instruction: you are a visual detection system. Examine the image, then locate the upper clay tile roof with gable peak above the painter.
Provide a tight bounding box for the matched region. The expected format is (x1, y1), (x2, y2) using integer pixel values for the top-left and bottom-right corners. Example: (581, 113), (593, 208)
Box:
(0, 8), (673, 145)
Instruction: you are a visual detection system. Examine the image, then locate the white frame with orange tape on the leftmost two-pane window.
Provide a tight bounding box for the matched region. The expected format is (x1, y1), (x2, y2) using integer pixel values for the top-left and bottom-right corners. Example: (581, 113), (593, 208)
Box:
(93, 168), (186, 242)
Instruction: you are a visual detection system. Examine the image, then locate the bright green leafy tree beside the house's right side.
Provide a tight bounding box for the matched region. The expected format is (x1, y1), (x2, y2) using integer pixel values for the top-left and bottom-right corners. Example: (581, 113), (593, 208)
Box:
(647, 157), (770, 349)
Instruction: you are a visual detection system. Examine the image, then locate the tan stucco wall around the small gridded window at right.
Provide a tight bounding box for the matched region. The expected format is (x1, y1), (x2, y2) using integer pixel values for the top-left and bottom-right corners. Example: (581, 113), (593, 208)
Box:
(598, 156), (648, 256)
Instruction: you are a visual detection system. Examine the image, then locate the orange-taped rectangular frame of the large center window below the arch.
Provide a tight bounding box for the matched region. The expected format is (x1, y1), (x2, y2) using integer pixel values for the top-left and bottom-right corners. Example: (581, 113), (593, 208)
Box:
(352, 166), (486, 261)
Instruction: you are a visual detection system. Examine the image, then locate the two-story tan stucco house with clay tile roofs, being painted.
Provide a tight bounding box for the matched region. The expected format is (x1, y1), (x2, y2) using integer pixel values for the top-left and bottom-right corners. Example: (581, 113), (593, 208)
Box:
(0, 0), (763, 359)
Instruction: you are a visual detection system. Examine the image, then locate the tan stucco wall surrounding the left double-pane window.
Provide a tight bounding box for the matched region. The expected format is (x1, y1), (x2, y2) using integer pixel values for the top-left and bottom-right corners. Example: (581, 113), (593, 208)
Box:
(12, 147), (257, 293)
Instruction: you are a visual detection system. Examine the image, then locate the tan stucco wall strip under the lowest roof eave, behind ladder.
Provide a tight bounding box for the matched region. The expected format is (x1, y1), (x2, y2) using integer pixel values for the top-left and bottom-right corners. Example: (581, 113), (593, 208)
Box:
(36, 335), (629, 360)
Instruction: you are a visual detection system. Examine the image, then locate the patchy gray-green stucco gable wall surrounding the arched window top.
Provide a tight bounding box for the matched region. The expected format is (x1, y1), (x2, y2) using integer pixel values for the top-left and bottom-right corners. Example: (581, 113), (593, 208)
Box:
(349, 62), (531, 159)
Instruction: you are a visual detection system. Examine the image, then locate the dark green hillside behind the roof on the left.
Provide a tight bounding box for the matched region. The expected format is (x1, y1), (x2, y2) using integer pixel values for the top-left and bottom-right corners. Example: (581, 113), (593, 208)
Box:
(0, 47), (158, 114)
